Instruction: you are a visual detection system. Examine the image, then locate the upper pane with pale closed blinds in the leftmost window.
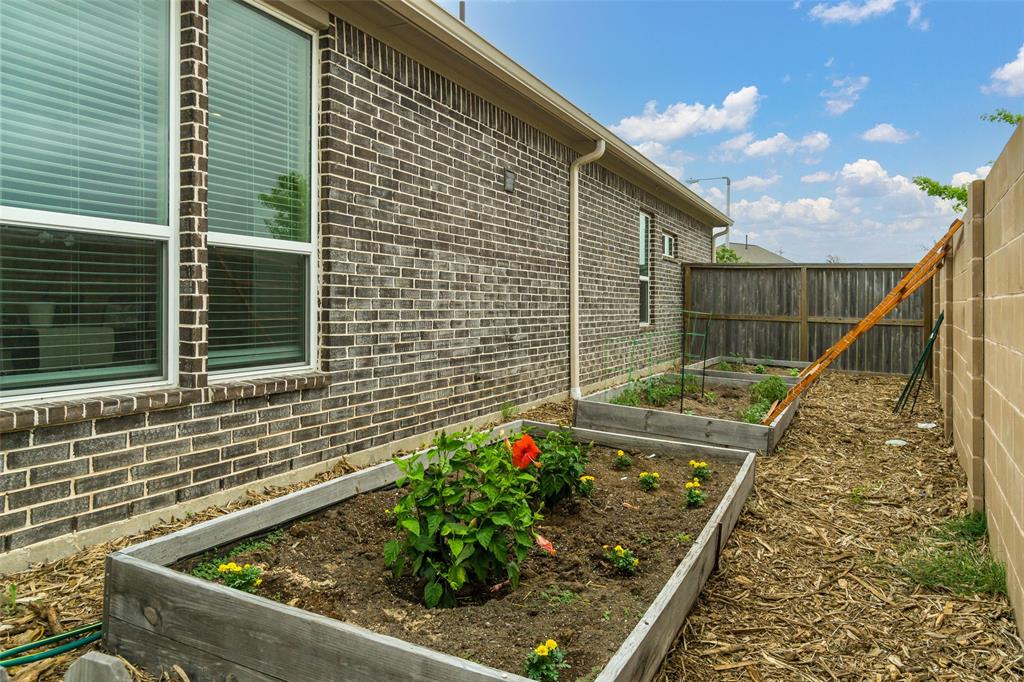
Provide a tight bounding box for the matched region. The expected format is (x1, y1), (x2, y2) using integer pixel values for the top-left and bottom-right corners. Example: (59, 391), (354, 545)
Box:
(0, 0), (170, 225)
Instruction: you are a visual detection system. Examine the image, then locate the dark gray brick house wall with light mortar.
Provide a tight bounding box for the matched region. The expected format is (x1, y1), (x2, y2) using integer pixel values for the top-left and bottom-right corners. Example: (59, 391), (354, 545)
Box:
(0, 0), (711, 551)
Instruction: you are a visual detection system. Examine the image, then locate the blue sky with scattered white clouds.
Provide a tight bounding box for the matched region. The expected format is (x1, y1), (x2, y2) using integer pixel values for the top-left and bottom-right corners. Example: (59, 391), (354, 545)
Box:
(441, 0), (1024, 262)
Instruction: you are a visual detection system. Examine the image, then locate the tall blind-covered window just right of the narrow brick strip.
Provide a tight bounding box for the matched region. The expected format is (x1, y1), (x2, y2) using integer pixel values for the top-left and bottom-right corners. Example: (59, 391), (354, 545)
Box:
(208, 0), (313, 372)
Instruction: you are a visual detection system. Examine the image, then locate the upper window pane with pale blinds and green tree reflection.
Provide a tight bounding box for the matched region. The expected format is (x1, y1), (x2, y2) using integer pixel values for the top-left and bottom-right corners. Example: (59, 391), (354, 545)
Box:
(203, 0), (312, 242)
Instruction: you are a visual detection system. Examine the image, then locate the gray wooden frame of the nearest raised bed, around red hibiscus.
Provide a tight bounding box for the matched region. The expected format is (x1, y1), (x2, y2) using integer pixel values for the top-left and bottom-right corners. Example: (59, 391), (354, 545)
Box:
(103, 421), (755, 682)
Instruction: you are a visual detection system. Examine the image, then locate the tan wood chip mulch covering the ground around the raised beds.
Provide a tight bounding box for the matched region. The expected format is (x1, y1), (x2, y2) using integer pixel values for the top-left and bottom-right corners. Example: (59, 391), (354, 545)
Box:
(0, 373), (1024, 682)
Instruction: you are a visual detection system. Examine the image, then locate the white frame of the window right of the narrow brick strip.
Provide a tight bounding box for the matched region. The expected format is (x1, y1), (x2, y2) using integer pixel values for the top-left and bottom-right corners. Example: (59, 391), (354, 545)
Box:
(207, 0), (321, 383)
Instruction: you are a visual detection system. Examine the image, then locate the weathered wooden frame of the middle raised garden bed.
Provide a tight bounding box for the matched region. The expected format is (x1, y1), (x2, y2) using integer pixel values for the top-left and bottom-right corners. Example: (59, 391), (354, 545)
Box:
(574, 374), (800, 453)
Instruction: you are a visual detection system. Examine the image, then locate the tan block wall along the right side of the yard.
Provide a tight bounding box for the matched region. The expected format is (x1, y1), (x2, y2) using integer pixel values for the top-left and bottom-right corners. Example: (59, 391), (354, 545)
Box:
(936, 120), (1024, 630)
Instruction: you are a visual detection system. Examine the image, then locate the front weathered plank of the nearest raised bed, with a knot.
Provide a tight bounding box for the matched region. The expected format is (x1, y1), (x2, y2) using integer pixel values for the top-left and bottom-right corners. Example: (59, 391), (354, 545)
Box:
(106, 552), (526, 682)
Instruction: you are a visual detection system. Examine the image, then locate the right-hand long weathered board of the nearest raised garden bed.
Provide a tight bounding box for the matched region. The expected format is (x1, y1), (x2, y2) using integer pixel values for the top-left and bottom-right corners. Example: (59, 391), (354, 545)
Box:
(595, 455), (755, 682)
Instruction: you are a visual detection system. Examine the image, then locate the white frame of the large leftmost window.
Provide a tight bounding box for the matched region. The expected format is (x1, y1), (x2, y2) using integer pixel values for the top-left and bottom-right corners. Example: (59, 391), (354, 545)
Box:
(0, 0), (181, 407)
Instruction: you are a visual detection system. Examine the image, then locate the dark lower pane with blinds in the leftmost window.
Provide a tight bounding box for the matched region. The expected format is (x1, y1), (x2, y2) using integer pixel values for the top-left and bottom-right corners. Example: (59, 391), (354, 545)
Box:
(0, 225), (165, 393)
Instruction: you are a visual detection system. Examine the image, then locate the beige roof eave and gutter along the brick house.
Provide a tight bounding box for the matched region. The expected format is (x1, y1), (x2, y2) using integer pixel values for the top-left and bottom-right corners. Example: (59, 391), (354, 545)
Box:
(271, 0), (732, 227)
